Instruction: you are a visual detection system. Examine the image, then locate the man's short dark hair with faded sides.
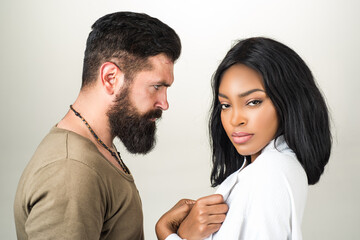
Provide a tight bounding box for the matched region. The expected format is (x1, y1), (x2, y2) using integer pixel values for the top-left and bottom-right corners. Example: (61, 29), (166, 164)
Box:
(82, 12), (181, 88)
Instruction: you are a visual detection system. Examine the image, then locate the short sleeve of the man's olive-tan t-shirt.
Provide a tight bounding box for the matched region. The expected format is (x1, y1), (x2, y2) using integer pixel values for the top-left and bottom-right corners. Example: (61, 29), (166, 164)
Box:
(25, 159), (106, 239)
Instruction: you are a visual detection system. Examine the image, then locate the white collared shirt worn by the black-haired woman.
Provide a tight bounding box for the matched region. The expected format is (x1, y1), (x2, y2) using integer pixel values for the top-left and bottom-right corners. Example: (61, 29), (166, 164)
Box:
(166, 137), (308, 240)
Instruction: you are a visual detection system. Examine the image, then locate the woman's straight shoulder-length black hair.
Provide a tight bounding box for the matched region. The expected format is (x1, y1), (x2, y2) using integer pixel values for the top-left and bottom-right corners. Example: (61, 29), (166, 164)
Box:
(209, 37), (332, 187)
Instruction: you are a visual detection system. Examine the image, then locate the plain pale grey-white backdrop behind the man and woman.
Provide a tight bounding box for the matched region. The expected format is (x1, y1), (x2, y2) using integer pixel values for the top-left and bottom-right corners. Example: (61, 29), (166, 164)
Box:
(0, 0), (360, 240)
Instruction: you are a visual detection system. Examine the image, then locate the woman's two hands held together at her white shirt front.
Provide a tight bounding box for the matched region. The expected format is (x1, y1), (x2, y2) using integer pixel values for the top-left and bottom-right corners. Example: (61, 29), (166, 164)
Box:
(156, 194), (228, 240)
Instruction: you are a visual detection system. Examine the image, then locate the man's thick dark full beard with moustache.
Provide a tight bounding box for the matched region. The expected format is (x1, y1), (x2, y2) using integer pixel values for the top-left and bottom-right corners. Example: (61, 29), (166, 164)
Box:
(107, 86), (162, 154)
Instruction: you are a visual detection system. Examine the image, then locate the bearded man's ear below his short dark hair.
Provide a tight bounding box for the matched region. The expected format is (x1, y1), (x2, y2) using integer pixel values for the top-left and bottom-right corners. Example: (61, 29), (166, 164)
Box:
(100, 62), (124, 95)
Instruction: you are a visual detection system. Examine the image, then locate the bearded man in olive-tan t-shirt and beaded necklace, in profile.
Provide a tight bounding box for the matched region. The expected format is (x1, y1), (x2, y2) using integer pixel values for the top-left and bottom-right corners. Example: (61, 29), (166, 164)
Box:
(14, 12), (181, 240)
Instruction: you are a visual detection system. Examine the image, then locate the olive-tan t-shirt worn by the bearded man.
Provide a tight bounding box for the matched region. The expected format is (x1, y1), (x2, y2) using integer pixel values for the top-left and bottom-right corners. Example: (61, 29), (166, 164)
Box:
(14, 127), (144, 240)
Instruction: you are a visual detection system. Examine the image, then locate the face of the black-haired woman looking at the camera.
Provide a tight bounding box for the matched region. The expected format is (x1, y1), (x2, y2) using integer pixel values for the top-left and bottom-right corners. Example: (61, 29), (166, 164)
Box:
(218, 64), (278, 162)
